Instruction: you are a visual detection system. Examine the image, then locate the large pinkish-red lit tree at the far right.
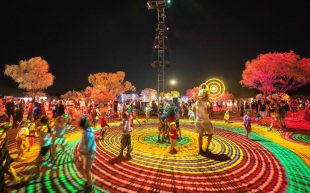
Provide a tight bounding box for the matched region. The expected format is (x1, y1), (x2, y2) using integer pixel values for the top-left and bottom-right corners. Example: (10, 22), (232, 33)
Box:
(240, 51), (310, 95)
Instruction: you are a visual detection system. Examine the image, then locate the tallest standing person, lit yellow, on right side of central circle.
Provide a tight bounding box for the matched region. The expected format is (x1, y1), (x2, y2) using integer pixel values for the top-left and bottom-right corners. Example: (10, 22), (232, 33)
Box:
(194, 83), (214, 155)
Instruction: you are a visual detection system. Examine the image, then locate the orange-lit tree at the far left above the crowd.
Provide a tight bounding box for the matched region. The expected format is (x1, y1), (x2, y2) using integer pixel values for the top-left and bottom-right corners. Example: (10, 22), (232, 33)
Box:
(4, 57), (54, 96)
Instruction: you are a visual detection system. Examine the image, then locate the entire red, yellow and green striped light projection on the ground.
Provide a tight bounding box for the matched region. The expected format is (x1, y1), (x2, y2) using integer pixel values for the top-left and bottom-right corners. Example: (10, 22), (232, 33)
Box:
(6, 122), (310, 192)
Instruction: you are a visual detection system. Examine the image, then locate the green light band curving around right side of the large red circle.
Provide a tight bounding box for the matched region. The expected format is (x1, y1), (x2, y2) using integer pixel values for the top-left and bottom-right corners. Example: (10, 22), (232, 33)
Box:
(214, 124), (310, 192)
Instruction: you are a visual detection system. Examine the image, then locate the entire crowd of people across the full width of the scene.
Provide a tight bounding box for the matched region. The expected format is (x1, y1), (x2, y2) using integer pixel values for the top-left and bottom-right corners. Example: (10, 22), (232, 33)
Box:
(0, 92), (309, 191)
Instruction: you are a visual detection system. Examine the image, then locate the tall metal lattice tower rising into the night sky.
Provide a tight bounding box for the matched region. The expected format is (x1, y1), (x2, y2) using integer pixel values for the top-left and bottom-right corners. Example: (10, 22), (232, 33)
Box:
(147, 0), (171, 96)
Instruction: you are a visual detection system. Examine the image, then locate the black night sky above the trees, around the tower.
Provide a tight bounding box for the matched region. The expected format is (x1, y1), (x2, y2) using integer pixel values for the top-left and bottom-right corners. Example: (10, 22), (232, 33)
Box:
(0, 0), (310, 96)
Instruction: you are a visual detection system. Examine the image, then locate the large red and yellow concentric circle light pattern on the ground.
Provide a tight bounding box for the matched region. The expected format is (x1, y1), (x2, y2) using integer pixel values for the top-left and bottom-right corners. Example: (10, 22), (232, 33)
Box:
(81, 125), (287, 192)
